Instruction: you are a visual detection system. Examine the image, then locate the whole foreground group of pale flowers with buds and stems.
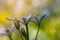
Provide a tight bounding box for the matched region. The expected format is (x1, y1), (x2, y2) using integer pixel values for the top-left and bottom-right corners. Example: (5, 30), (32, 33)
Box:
(0, 14), (47, 40)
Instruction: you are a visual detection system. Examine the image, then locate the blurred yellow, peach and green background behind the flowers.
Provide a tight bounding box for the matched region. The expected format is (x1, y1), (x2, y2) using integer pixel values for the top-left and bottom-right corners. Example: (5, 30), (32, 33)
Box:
(0, 0), (60, 40)
